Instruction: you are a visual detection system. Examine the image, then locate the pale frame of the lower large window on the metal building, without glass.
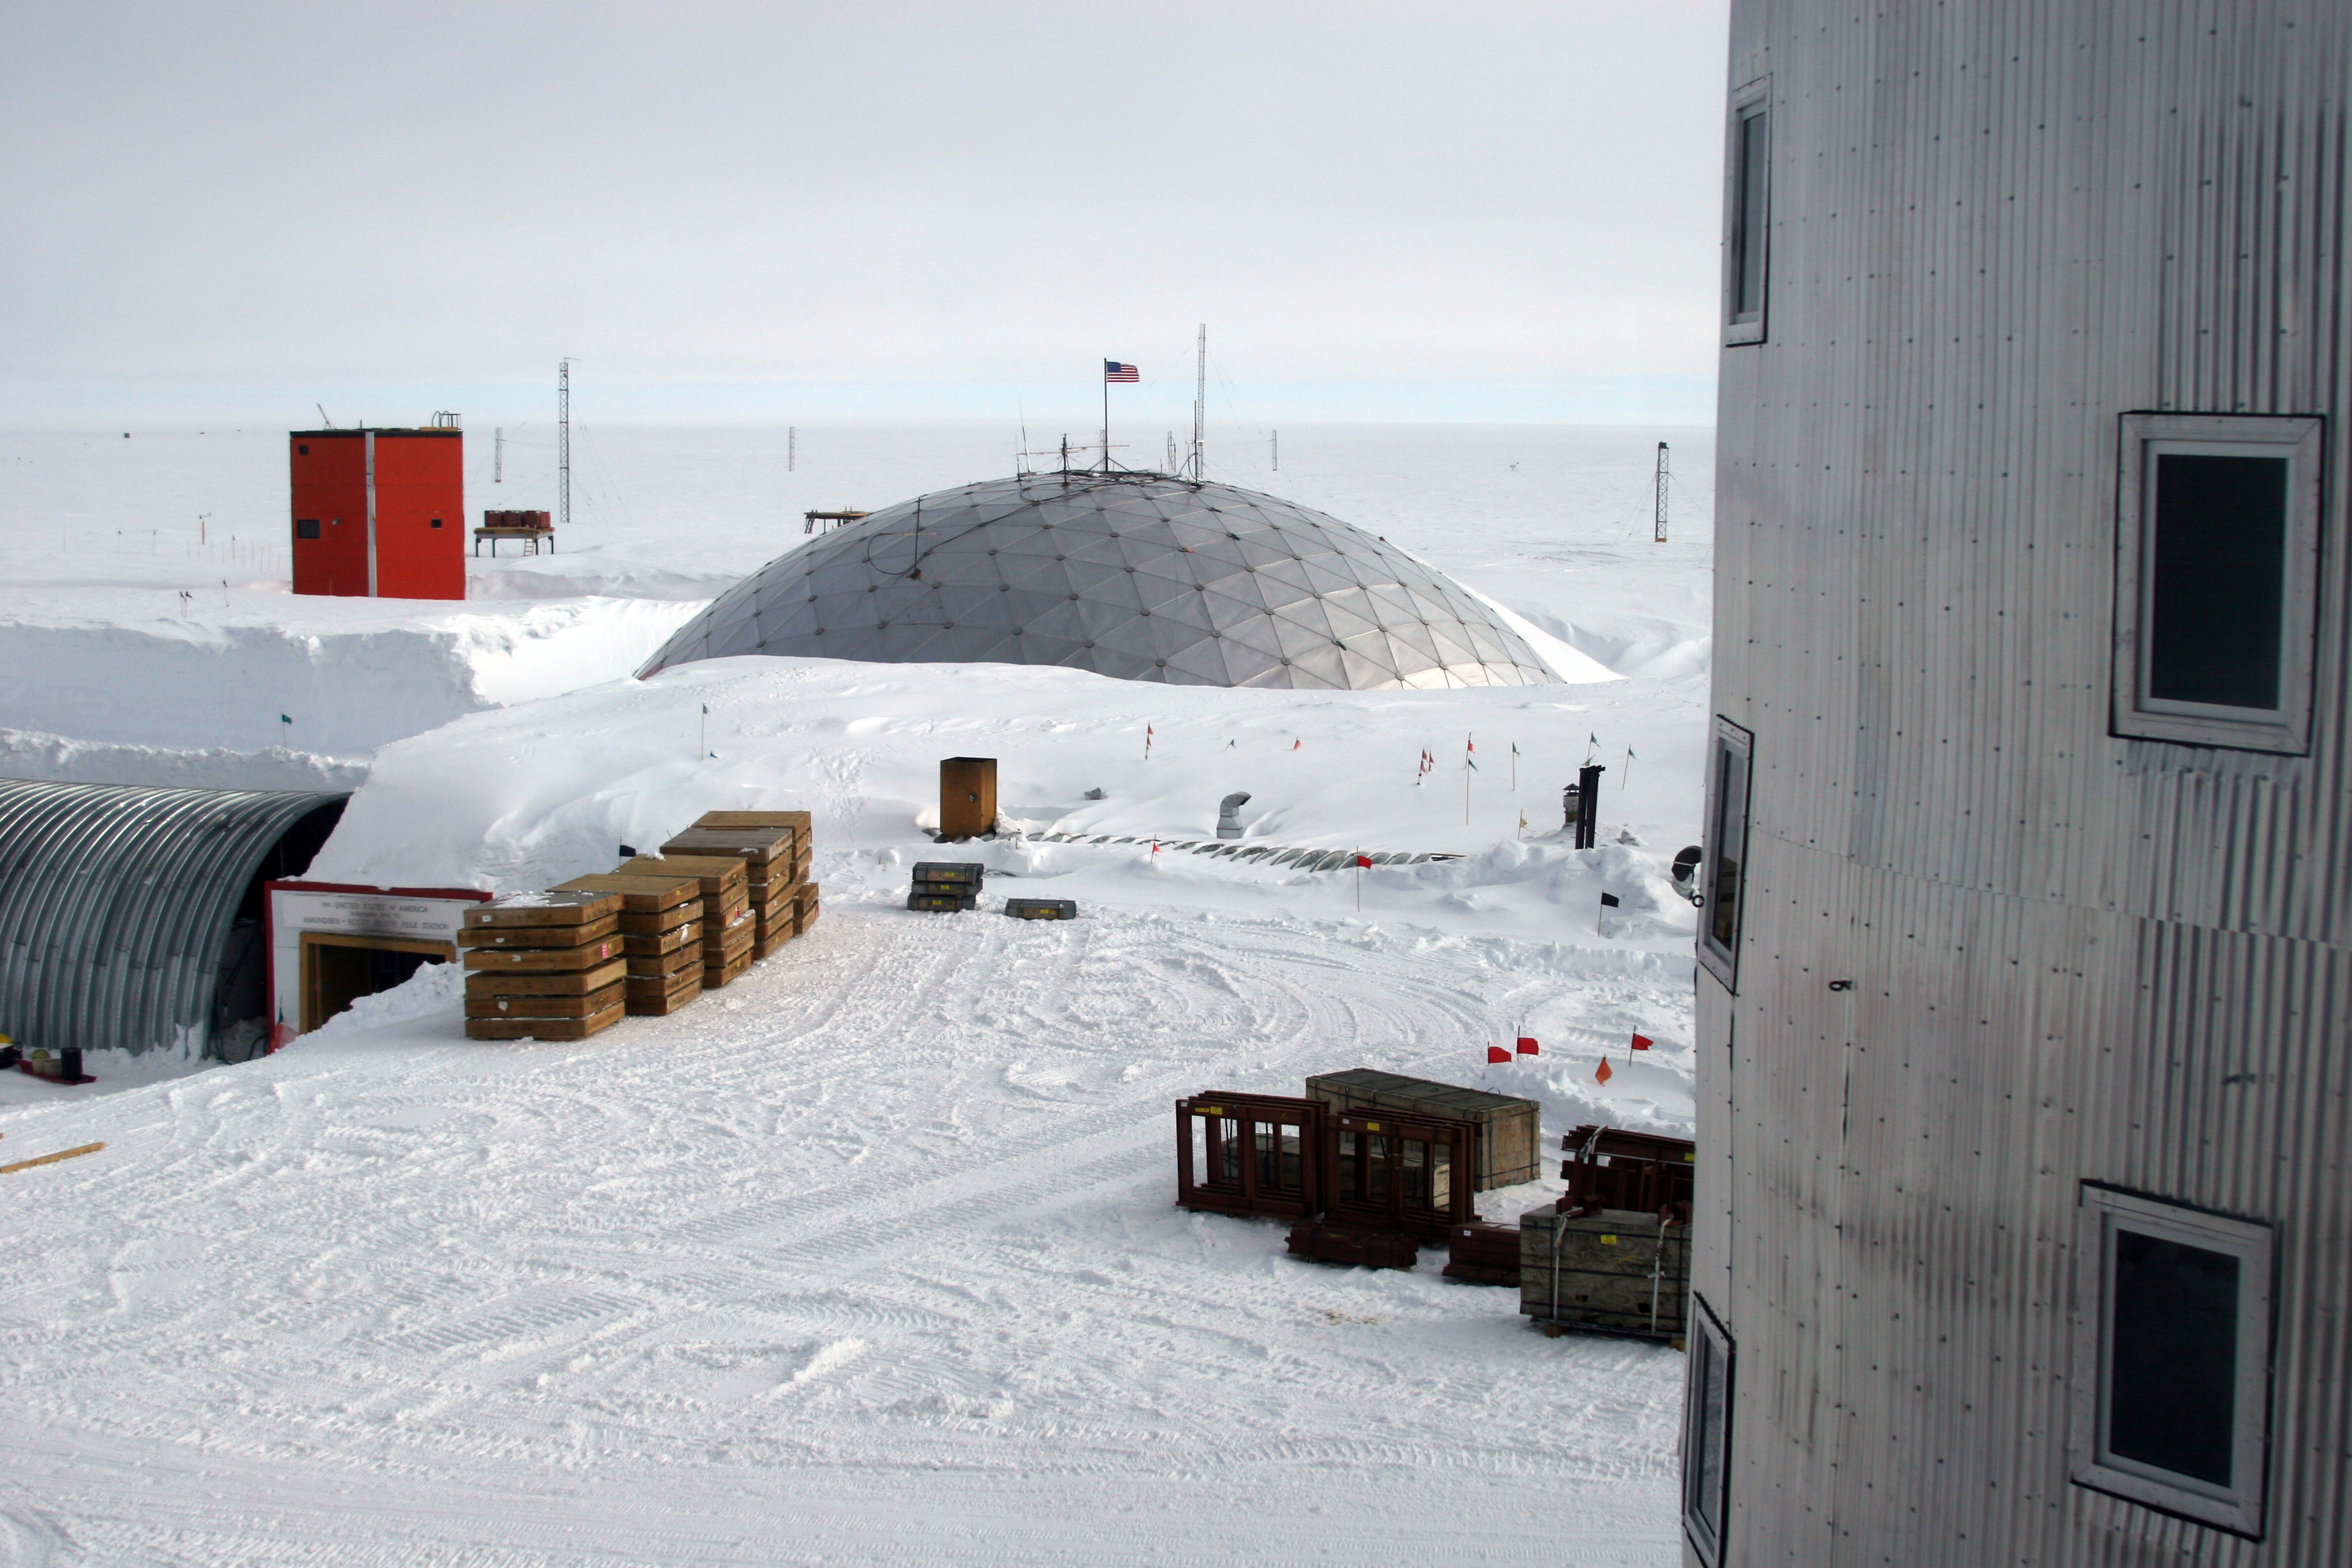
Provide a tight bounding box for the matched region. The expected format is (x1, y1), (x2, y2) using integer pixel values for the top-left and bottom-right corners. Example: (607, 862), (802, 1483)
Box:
(2070, 1183), (2274, 1540)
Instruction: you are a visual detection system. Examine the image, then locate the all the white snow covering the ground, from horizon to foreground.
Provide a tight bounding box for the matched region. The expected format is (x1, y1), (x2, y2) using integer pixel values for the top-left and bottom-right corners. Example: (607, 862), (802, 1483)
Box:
(0, 428), (1708, 1565)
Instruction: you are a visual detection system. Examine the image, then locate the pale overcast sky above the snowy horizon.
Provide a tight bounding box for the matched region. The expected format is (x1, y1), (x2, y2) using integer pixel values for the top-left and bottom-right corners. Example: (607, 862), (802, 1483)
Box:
(0, 0), (1724, 428)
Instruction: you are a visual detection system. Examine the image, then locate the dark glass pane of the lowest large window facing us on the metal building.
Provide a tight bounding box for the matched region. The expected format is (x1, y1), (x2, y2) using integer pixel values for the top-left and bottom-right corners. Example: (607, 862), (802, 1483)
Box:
(2108, 1230), (2239, 1485)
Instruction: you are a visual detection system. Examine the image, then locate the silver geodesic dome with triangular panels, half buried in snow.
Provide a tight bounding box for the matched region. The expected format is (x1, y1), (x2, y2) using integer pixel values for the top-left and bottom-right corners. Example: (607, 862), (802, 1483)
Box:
(638, 473), (1557, 691)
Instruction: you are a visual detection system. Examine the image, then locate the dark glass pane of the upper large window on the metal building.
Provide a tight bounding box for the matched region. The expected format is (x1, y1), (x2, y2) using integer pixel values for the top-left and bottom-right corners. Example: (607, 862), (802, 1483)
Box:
(2145, 451), (2286, 710)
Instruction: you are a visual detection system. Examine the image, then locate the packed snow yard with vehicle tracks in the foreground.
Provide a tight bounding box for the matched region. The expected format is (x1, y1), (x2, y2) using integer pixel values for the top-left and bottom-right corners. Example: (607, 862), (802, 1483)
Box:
(0, 900), (1689, 1568)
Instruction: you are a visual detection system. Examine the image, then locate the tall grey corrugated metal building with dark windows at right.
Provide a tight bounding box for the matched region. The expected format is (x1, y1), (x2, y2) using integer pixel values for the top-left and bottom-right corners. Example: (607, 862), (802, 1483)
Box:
(1684, 0), (2352, 1568)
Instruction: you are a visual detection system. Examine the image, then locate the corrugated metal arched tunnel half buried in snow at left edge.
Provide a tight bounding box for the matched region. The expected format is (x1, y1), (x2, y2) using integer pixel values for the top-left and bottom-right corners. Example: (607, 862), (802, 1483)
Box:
(0, 778), (350, 1061)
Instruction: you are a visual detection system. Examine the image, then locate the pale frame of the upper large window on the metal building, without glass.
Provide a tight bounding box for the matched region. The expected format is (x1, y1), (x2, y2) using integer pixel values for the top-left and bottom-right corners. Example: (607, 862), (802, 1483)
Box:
(2112, 413), (2324, 757)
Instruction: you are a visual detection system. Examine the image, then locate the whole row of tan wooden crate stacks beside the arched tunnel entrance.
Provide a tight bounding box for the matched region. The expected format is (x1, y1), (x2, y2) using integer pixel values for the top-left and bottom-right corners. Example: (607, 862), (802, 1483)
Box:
(458, 811), (818, 1039)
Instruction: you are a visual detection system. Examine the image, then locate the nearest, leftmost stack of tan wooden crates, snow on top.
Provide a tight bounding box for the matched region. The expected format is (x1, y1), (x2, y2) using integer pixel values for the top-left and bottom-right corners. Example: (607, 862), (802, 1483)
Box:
(458, 891), (626, 1039)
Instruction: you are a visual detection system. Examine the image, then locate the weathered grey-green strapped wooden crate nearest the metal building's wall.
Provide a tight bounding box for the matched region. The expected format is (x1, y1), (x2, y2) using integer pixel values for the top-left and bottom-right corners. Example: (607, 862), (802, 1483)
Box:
(1520, 1206), (1691, 1340)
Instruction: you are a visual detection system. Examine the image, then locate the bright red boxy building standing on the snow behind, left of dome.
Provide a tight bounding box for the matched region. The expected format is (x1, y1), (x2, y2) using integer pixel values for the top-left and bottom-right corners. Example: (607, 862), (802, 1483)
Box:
(287, 426), (466, 599)
